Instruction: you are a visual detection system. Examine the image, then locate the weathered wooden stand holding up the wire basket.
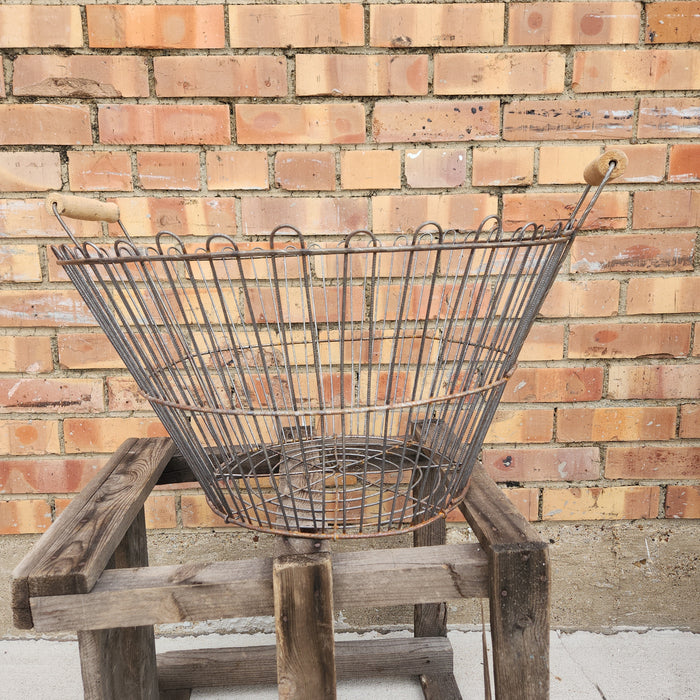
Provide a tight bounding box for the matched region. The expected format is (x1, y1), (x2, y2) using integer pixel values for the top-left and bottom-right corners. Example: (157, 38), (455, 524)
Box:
(12, 438), (549, 700)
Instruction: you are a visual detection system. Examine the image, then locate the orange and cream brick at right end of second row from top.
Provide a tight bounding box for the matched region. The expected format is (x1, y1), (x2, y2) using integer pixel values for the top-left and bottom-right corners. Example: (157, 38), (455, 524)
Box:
(571, 49), (700, 92)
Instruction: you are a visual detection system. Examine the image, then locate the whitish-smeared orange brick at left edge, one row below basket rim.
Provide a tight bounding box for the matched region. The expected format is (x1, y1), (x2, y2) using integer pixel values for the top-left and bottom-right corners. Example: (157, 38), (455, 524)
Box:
(0, 289), (96, 328)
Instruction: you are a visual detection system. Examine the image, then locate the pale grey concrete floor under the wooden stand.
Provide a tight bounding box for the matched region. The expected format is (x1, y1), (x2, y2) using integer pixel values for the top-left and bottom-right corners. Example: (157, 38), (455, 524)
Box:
(0, 630), (700, 700)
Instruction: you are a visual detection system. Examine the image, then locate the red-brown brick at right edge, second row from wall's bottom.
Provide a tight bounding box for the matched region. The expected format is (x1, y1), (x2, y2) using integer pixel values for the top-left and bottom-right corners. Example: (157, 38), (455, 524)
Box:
(605, 445), (700, 479)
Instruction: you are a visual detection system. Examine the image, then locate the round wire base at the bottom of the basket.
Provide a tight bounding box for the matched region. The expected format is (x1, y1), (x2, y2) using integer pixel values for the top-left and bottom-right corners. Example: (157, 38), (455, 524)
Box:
(211, 436), (471, 539)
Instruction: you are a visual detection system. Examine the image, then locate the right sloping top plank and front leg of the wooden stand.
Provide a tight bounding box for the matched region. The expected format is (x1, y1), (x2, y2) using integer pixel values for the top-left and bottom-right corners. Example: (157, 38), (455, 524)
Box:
(460, 467), (549, 700)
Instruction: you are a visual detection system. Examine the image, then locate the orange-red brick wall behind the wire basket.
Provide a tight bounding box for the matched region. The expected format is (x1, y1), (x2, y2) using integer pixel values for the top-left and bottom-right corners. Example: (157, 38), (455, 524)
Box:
(0, 0), (700, 535)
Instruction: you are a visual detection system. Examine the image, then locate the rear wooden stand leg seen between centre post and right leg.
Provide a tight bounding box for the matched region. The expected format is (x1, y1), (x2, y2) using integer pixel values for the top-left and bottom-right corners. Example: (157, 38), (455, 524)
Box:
(413, 518), (462, 700)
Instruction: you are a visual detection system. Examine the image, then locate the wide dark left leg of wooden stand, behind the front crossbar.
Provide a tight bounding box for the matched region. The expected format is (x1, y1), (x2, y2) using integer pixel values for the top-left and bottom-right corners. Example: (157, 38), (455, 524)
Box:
(78, 508), (158, 700)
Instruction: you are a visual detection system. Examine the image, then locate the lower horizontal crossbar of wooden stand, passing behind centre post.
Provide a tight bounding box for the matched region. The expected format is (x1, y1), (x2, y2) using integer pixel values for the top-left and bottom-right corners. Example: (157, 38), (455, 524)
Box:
(158, 637), (453, 692)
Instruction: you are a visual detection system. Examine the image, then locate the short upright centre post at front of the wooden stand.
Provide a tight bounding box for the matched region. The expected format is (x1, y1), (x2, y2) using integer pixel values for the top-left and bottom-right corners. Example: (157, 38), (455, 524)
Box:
(272, 542), (336, 700)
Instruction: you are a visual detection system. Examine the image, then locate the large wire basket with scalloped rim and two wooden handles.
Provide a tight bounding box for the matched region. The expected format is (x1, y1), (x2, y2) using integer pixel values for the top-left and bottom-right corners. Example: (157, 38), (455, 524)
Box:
(49, 153), (624, 537)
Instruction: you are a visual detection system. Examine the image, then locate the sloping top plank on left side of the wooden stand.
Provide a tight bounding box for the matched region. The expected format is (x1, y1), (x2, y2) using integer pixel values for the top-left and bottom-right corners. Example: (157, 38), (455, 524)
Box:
(12, 438), (175, 628)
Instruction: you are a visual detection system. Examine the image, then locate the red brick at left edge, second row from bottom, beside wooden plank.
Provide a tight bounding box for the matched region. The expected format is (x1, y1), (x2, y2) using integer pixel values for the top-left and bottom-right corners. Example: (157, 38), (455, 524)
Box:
(0, 457), (105, 493)
